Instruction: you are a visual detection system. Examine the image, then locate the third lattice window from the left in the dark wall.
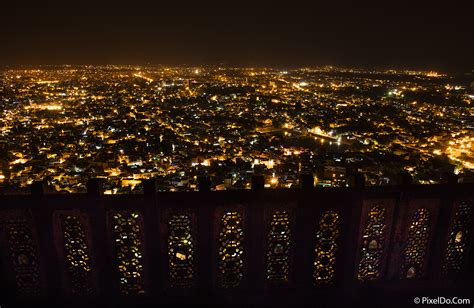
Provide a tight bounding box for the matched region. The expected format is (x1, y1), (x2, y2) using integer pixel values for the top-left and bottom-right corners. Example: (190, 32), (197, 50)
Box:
(112, 212), (145, 295)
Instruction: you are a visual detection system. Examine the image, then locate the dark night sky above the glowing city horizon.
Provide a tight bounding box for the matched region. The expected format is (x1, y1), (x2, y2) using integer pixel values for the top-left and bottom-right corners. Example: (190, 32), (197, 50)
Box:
(0, 0), (474, 71)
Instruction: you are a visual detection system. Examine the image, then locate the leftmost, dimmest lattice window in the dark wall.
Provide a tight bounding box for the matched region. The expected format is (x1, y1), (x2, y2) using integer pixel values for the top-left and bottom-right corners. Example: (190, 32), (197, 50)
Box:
(2, 212), (40, 297)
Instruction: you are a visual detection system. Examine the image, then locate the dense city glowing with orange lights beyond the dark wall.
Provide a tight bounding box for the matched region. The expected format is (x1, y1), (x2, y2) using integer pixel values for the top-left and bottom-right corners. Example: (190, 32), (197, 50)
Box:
(0, 66), (474, 194)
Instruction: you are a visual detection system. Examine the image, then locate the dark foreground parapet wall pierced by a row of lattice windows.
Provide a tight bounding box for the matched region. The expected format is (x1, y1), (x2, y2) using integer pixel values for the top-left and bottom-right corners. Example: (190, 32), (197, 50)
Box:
(0, 181), (474, 308)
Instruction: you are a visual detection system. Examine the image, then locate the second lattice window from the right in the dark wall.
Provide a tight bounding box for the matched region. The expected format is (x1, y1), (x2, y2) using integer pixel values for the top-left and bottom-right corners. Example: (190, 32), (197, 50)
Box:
(402, 208), (430, 279)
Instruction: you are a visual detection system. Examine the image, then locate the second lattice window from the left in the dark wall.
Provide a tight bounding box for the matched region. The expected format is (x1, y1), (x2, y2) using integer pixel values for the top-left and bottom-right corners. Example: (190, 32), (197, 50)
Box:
(62, 215), (94, 295)
